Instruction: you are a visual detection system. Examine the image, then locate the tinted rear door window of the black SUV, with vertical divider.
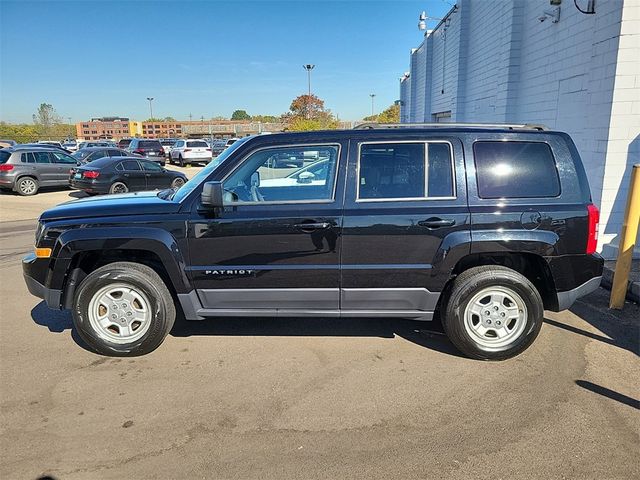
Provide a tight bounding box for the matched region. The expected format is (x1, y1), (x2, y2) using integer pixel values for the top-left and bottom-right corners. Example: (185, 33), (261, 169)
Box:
(358, 142), (454, 200)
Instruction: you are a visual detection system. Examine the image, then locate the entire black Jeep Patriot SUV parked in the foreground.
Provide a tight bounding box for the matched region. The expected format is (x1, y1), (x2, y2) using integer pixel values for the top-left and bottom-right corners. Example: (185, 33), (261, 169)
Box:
(23, 124), (603, 359)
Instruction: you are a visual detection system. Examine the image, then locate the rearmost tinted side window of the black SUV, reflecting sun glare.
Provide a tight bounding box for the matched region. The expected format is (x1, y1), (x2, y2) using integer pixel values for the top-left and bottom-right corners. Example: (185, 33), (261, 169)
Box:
(473, 142), (560, 198)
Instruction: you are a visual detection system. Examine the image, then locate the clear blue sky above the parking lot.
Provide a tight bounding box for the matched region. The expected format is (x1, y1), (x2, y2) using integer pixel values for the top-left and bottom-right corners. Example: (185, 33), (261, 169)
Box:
(0, 0), (453, 123)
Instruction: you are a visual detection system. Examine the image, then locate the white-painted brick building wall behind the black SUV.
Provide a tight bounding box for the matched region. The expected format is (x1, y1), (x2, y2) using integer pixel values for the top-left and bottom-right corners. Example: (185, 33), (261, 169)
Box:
(400, 0), (640, 258)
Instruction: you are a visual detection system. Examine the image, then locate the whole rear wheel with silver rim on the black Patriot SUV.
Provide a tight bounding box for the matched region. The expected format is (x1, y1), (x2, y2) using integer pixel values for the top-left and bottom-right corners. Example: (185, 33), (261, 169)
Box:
(442, 266), (544, 360)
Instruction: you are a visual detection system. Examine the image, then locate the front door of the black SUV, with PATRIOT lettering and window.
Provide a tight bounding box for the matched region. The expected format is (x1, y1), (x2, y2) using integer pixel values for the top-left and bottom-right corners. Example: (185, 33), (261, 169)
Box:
(188, 142), (346, 315)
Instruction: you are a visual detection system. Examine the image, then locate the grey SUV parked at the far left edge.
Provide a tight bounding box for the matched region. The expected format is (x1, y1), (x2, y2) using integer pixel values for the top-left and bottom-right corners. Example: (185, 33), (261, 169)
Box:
(0, 145), (76, 195)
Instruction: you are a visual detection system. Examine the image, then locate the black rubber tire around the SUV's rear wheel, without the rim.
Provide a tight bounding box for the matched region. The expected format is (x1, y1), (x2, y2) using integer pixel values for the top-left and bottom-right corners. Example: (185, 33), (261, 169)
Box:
(444, 270), (544, 360)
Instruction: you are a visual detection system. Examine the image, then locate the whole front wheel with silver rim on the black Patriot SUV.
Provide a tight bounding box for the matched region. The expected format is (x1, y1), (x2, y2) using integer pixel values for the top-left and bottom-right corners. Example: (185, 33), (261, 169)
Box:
(72, 262), (176, 357)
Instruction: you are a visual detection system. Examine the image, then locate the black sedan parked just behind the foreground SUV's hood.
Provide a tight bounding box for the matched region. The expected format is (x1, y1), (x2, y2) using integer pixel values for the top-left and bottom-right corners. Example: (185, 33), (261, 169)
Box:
(68, 157), (187, 194)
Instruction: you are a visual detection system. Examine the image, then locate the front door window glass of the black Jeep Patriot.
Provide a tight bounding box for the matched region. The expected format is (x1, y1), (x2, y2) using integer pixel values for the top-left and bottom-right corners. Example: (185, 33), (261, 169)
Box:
(223, 145), (340, 204)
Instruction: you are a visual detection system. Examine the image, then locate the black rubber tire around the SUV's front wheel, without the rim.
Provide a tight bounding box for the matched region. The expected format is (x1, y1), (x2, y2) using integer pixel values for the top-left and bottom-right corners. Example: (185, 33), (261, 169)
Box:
(72, 268), (170, 356)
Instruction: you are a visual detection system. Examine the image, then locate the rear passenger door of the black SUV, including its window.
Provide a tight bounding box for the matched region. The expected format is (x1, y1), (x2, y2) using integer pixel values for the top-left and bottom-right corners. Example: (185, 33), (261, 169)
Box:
(341, 134), (470, 319)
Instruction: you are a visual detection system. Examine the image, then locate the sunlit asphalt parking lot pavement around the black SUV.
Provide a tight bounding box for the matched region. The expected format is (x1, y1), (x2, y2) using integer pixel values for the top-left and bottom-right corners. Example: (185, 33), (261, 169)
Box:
(0, 173), (640, 480)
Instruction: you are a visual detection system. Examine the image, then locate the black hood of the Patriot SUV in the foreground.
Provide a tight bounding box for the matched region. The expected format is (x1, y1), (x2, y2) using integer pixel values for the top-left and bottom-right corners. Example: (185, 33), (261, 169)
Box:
(40, 192), (180, 220)
